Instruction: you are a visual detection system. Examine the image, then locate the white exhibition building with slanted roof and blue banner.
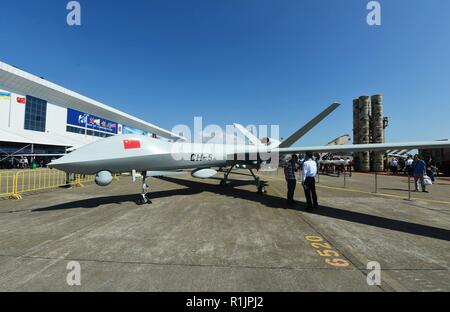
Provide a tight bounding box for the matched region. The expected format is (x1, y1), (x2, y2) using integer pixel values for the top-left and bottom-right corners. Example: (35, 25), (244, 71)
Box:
(0, 62), (176, 168)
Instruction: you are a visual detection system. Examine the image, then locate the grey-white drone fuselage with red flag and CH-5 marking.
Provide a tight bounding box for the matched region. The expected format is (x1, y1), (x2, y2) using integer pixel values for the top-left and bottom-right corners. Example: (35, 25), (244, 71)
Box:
(50, 135), (269, 174)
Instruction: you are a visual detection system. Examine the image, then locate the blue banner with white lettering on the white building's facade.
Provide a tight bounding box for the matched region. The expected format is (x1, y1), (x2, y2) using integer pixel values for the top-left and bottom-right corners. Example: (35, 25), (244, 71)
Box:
(67, 108), (118, 134)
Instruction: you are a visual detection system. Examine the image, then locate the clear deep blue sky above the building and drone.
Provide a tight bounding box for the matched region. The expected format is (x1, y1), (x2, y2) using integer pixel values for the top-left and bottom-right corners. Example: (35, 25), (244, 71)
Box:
(0, 0), (450, 145)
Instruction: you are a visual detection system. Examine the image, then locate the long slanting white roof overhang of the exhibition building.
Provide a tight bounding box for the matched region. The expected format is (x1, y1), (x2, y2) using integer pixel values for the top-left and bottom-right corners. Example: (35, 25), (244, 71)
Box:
(0, 62), (182, 139)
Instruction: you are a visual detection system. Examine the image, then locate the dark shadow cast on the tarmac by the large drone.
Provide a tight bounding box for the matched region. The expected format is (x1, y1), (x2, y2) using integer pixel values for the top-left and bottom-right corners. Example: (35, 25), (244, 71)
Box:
(33, 177), (450, 241)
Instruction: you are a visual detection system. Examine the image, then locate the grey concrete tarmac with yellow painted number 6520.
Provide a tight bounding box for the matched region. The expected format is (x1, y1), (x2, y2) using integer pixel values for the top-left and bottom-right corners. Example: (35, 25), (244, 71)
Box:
(0, 171), (450, 292)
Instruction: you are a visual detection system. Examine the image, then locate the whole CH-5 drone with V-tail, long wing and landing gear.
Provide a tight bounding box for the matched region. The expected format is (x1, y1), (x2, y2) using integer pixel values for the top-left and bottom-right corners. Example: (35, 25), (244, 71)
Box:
(49, 103), (450, 204)
